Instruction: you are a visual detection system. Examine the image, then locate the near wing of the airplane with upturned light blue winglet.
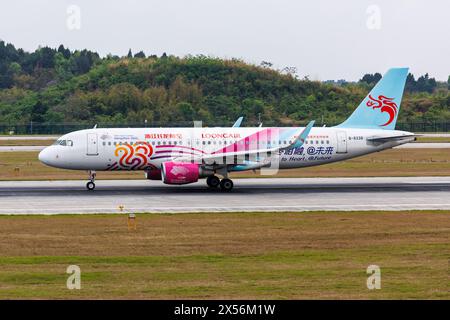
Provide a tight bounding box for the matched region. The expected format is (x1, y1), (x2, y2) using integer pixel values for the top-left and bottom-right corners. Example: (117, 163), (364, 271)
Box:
(174, 120), (315, 166)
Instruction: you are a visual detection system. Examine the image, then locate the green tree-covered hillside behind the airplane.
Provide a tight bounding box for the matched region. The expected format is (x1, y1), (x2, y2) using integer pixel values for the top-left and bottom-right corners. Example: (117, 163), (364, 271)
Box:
(0, 41), (450, 129)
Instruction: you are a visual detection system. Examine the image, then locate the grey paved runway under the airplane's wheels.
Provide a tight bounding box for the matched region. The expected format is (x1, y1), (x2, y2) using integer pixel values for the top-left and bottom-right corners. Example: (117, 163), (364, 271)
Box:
(0, 177), (450, 214)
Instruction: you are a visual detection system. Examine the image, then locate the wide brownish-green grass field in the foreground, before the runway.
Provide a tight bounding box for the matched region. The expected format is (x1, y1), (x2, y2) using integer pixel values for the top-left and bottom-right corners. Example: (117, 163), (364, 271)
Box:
(0, 211), (450, 299)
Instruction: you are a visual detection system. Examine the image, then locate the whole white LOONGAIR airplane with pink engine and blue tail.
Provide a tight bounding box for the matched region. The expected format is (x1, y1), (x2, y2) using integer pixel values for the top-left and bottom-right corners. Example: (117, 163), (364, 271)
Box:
(39, 68), (416, 191)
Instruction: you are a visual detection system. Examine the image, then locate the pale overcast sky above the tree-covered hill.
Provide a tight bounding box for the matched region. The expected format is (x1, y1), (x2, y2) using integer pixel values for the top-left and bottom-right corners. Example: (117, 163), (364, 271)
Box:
(0, 0), (450, 81)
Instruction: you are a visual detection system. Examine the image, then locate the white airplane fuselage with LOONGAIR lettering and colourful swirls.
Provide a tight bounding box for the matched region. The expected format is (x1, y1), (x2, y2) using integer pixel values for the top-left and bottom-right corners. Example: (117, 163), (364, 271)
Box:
(39, 127), (414, 171)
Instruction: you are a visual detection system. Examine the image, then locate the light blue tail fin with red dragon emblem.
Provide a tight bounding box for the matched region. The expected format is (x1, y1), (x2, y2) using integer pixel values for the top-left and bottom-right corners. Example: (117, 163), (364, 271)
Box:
(337, 68), (408, 130)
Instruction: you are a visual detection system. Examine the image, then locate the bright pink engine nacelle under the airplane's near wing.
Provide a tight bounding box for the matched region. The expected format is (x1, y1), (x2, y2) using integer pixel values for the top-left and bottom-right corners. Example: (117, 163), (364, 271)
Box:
(161, 162), (201, 184)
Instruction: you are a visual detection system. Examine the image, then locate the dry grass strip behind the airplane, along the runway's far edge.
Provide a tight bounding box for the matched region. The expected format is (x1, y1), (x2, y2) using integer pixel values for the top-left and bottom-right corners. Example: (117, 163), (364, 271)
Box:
(0, 148), (450, 180)
